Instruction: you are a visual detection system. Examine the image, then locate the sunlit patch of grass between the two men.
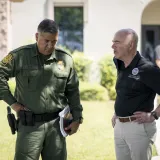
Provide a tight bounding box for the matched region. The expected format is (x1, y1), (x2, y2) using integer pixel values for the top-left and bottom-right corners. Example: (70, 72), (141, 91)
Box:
(67, 102), (115, 160)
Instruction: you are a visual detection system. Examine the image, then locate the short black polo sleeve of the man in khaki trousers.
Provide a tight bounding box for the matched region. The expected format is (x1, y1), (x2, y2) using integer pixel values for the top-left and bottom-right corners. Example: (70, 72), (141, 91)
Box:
(140, 65), (160, 95)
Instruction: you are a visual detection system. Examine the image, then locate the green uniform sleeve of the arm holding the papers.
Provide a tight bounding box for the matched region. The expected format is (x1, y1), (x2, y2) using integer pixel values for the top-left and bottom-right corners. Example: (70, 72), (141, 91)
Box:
(65, 60), (83, 120)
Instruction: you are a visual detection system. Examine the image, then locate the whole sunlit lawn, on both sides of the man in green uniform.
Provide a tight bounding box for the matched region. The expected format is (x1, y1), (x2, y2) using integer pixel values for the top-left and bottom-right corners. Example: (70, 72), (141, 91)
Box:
(0, 101), (156, 160)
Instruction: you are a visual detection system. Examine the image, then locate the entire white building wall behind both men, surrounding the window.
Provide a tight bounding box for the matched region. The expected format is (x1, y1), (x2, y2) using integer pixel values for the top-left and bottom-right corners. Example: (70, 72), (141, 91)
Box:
(12, 0), (154, 58)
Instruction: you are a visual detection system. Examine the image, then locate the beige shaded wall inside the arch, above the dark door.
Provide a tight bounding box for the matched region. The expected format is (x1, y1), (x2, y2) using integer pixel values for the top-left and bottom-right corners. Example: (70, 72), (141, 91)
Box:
(142, 0), (160, 25)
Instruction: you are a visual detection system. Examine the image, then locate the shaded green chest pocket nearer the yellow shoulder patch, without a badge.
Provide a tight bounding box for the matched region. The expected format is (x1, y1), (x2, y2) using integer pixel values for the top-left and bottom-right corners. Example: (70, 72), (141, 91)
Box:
(22, 69), (42, 91)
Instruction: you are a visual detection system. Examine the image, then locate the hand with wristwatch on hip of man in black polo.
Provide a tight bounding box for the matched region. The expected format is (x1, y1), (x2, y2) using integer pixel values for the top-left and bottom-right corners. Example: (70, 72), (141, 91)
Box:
(134, 111), (155, 124)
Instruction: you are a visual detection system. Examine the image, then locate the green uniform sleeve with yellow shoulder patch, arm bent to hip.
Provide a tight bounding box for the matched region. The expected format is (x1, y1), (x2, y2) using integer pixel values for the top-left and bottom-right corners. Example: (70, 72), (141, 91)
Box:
(0, 53), (16, 105)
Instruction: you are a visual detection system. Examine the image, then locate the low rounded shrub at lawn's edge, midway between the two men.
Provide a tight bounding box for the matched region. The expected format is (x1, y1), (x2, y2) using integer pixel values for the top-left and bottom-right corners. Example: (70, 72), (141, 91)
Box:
(80, 82), (109, 101)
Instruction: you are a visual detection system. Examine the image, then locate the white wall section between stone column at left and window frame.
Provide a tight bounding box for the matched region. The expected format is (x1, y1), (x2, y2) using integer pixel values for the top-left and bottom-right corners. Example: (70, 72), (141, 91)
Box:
(11, 0), (45, 49)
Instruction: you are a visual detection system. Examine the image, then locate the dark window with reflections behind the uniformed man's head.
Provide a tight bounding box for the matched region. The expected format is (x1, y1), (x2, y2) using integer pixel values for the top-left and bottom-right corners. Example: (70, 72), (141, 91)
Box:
(54, 6), (83, 52)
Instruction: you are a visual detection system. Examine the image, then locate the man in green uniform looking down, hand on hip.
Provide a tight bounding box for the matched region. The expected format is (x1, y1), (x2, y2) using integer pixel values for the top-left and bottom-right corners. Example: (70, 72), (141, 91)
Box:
(0, 19), (82, 160)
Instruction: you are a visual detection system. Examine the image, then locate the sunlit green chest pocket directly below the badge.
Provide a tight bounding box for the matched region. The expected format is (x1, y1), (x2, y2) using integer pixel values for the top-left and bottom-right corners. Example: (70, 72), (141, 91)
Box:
(54, 71), (68, 92)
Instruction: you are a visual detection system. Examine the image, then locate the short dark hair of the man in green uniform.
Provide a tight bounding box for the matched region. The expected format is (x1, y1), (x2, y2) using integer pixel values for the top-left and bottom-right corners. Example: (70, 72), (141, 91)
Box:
(37, 19), (58, 34)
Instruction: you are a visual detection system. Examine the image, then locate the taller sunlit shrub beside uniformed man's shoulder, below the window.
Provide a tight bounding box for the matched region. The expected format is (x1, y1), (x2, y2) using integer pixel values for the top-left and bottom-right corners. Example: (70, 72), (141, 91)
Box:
(72, 52), (92, 81)
